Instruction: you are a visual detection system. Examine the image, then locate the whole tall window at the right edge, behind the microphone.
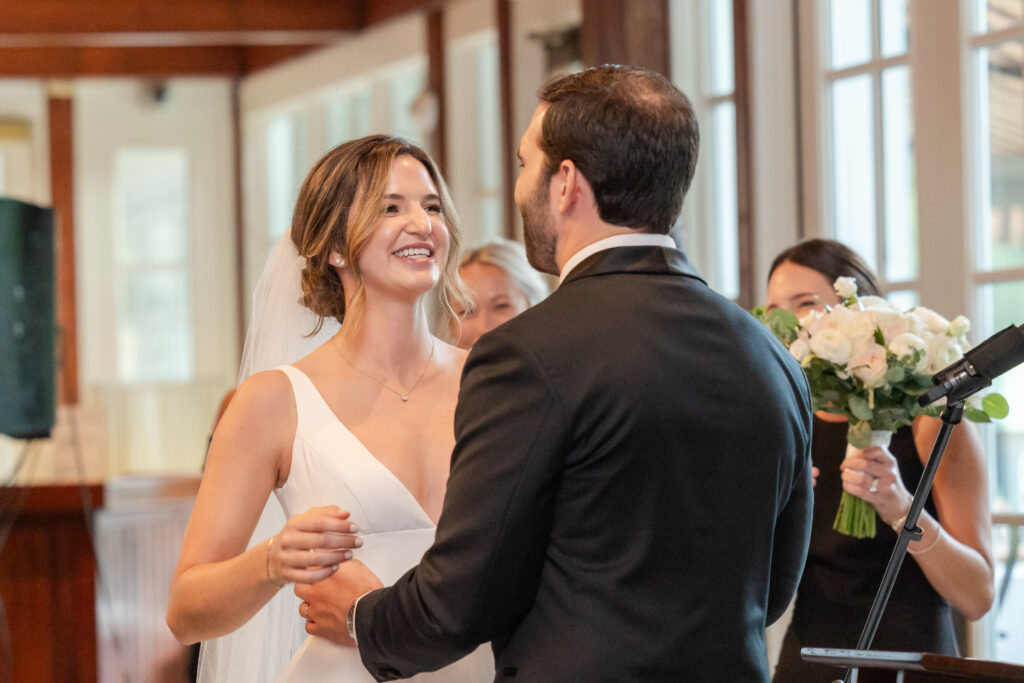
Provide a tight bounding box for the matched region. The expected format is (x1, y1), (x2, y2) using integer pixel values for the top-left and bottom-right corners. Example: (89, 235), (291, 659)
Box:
(968, 0), (1024, 661)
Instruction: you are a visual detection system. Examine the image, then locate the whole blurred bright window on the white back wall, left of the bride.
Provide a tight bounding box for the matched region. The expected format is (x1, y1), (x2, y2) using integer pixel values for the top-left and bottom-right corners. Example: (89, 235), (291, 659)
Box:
(114, 148), (195, 383)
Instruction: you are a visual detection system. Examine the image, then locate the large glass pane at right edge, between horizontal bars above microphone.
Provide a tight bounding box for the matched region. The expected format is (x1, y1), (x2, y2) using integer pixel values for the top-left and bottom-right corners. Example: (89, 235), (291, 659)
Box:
(977, 41), (1024, 270)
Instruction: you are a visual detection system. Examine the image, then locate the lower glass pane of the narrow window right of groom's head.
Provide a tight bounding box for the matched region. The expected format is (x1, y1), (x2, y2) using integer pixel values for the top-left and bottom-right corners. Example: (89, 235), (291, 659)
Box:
(711, 101), (739, 299)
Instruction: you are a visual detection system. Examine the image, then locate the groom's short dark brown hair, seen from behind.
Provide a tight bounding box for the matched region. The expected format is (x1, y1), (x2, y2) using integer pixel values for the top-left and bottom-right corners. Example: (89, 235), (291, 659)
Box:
(539, 65), (700, 233)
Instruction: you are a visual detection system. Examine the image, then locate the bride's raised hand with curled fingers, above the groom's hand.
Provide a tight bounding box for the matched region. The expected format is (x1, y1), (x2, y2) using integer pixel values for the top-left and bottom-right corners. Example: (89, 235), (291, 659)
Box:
(266, 505), (362, 585)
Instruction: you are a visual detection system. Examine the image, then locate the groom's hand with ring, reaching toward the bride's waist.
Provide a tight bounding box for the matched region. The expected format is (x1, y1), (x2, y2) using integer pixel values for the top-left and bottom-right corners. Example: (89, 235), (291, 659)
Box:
(295, 560), (384, 647)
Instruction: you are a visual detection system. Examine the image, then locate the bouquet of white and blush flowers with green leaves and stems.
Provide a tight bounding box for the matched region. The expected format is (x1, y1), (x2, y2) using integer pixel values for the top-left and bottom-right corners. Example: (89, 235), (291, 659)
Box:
(752, 278), (1009, 539)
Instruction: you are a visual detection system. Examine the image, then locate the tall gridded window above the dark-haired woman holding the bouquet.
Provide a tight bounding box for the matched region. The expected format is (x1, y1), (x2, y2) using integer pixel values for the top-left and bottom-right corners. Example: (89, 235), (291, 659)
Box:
(823, 0), (919, 290)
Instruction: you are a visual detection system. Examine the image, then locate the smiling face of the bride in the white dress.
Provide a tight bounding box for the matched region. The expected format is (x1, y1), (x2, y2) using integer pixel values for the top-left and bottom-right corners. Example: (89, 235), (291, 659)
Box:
(350, 155), (449, 297)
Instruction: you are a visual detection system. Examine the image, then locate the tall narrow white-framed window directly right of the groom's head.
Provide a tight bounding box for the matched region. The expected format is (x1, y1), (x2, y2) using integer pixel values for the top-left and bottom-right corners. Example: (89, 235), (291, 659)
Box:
(670, 0), (739, 298)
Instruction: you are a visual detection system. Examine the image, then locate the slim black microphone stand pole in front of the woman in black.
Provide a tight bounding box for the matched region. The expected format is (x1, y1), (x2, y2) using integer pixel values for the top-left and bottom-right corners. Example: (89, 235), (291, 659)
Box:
(843, 398), (965, 683)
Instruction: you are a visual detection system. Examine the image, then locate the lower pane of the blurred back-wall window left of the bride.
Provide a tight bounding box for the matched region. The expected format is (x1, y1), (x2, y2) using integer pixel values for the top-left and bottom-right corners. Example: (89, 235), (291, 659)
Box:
(117, 269), (194, 382)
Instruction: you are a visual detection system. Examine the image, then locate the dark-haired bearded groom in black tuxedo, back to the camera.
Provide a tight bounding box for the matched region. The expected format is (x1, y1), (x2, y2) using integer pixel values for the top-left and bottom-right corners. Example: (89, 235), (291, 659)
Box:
(296, 67), (811, 682)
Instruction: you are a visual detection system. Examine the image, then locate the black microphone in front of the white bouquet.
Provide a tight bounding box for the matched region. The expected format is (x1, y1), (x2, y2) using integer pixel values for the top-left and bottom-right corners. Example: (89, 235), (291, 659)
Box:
(918, 325), (1024, 407)
